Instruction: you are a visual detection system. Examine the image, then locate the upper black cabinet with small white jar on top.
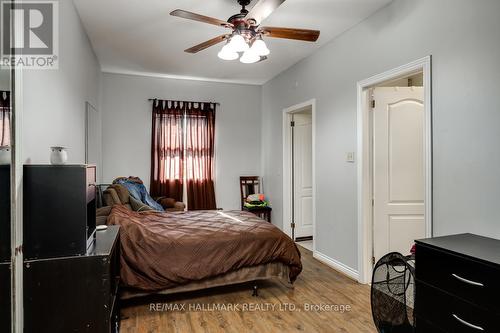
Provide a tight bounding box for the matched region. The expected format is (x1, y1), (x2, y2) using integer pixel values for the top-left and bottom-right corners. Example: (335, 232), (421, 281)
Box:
(23, 165), (96, 259)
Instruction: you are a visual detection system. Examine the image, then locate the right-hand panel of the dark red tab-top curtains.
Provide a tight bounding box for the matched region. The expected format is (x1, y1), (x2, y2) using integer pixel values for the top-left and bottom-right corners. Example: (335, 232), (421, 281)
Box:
(185, 103), (217, 210)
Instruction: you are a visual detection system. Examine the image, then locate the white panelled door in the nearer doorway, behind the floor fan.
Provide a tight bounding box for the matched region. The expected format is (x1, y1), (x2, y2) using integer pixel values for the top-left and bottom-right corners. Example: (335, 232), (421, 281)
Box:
(373, 87), (425, 260)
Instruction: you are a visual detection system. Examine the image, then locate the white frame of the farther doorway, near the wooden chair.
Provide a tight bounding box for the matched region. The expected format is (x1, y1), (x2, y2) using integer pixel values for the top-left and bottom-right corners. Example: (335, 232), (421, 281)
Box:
(283, 98), (316, 252)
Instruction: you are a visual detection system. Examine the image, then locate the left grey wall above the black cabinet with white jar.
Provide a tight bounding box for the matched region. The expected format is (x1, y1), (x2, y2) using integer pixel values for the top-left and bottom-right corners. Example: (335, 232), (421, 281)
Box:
(22, 0), (100, 163)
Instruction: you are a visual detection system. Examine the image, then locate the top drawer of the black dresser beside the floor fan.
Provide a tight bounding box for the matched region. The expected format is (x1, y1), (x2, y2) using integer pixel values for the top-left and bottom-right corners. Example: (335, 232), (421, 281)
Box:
(415, 244), (500, 313)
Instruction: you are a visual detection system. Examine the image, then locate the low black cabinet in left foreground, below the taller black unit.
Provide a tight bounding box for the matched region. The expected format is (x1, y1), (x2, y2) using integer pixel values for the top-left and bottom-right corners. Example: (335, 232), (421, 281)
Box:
(24, 226), (120, 333)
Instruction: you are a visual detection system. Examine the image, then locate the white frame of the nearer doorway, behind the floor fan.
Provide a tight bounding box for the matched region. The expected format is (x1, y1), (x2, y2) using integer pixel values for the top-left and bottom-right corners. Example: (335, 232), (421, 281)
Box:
(357, 56), (432, 284)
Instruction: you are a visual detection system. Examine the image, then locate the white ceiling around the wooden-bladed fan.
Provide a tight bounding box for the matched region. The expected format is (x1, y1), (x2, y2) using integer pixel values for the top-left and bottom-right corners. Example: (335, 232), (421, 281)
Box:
(74, 0), (391, 84)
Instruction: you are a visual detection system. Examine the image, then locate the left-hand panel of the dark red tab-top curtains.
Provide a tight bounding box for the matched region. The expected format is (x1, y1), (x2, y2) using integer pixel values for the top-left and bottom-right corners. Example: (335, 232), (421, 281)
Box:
(150, 100), (185, 201)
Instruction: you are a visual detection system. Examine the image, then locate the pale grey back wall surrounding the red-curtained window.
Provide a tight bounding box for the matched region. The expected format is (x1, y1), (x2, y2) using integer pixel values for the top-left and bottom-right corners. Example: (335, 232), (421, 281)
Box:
(102, 73), (261, 209)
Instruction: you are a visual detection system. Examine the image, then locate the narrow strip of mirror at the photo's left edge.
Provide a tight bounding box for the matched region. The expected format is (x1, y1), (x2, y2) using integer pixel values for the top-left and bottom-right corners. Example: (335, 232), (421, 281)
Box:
(0, 65), (13, 332)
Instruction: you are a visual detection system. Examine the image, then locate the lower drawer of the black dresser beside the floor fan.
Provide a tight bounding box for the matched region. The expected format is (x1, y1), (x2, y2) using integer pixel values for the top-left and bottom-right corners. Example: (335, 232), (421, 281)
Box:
(415, 280), (500, 333)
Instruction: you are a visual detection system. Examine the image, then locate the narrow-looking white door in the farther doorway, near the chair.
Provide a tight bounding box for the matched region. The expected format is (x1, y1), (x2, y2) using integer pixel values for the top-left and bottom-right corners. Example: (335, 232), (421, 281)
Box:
(293, 113), (313, 238)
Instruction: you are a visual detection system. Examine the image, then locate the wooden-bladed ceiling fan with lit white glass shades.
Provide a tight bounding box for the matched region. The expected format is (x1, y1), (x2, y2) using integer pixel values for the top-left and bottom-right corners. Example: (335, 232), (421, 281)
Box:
(170, 0), (320, 64)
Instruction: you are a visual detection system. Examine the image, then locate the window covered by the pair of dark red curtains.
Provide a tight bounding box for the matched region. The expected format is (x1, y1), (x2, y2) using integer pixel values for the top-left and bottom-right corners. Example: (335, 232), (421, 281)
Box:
(150, 101), (216, 210)
